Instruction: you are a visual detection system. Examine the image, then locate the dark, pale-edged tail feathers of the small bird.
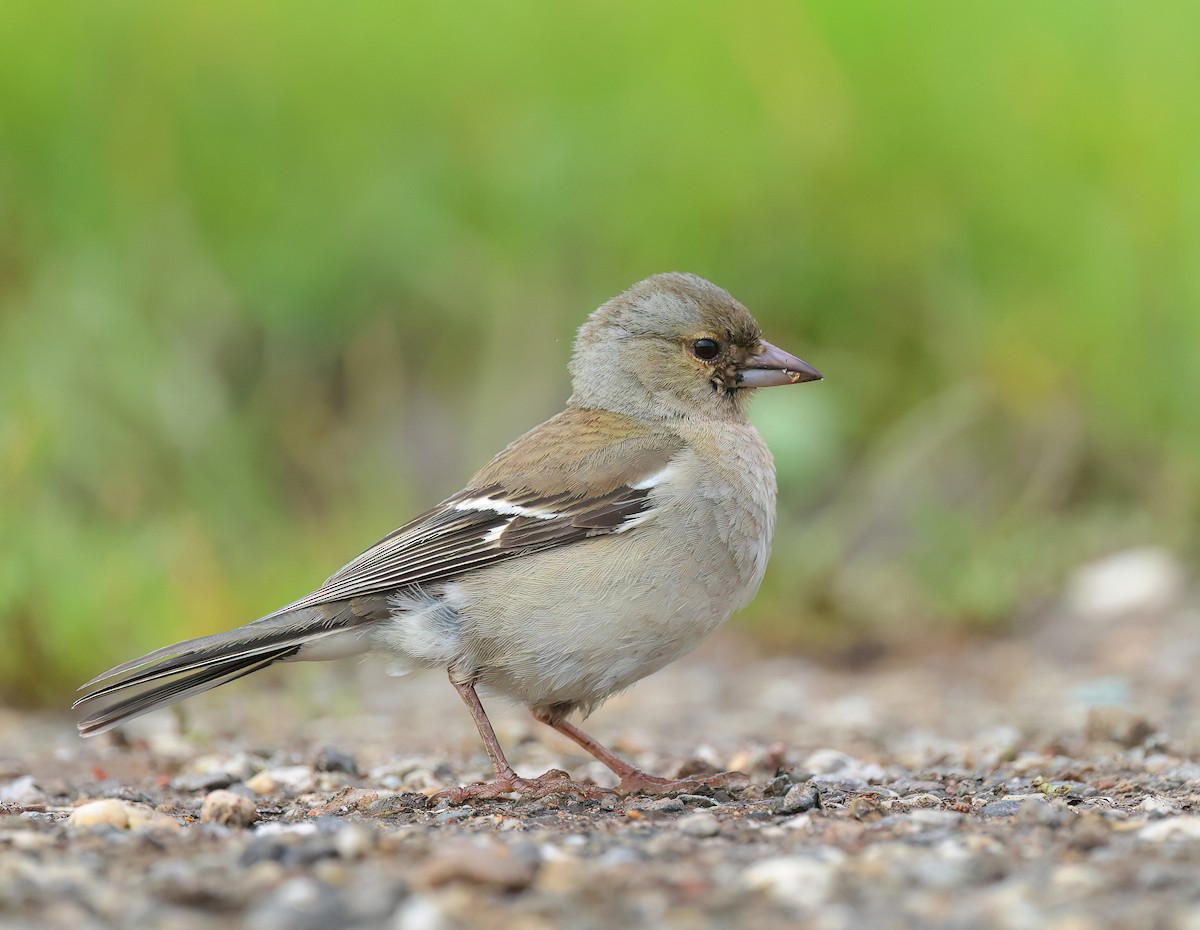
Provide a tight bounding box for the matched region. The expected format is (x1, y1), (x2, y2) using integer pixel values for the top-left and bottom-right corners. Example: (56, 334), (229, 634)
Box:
(72, 598), (386, 737)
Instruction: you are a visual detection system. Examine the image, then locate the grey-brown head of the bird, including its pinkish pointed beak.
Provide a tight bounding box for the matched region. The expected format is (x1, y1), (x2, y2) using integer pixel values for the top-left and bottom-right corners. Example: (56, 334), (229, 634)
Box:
(571, 272), (821, 419)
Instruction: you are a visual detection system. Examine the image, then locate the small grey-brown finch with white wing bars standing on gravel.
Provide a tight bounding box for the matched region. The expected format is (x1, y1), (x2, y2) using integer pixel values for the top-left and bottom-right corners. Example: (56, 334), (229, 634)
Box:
(74, 272), (822, 802)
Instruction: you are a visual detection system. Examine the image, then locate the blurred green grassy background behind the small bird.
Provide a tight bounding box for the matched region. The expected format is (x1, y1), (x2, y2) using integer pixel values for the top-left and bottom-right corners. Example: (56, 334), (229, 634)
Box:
(0, 0), (1200, 706)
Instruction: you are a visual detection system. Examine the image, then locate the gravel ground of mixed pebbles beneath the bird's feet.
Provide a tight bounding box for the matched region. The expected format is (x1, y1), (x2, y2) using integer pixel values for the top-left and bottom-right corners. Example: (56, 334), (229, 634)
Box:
(0, 552), (1200, 930)
